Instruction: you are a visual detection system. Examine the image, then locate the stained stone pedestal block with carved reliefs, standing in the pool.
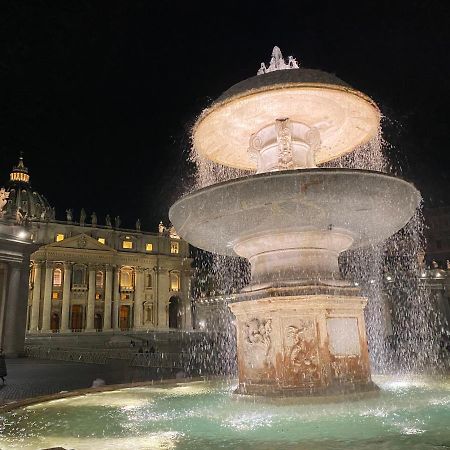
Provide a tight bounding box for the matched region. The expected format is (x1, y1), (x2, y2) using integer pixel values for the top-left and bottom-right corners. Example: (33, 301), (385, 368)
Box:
(230, 295), (376, 396)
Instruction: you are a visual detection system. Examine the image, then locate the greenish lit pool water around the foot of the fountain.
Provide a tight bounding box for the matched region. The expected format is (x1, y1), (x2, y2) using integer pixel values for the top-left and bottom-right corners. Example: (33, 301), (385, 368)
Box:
(0, 377), (450, 450)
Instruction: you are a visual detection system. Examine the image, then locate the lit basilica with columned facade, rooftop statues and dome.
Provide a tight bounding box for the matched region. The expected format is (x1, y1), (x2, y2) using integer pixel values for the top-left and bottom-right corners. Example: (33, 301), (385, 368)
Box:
(0, 158), (192, 348)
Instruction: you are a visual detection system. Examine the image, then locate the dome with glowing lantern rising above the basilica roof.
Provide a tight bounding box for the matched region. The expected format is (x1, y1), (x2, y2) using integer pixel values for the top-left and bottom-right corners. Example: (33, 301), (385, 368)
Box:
(0, 156), (55, 222)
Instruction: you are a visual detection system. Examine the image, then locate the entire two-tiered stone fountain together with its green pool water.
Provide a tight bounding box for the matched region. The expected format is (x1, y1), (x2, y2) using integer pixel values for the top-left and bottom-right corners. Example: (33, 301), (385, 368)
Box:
(0, 48), (450, 450)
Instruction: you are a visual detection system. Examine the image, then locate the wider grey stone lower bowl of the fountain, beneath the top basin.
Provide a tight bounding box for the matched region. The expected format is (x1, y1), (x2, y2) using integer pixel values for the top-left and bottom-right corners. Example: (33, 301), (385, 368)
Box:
(169, 169), (421, 256)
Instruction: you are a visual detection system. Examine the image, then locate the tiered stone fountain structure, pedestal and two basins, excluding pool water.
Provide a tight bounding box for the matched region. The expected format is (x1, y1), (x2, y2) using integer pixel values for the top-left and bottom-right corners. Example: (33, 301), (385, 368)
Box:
(169, 47), (421, 396)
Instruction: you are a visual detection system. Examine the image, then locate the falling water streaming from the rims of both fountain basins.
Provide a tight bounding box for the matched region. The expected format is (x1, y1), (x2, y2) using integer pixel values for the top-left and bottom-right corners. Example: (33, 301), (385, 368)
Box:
(186, 119), (445, 373)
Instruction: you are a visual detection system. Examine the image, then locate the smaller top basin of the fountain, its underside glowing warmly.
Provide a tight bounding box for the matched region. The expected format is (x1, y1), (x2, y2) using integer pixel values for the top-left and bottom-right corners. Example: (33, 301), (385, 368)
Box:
(193, 69), (380, 170)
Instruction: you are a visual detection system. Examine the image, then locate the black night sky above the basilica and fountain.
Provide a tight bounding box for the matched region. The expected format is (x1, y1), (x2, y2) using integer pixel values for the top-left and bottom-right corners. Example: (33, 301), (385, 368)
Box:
(0, 0), (450, 230)
